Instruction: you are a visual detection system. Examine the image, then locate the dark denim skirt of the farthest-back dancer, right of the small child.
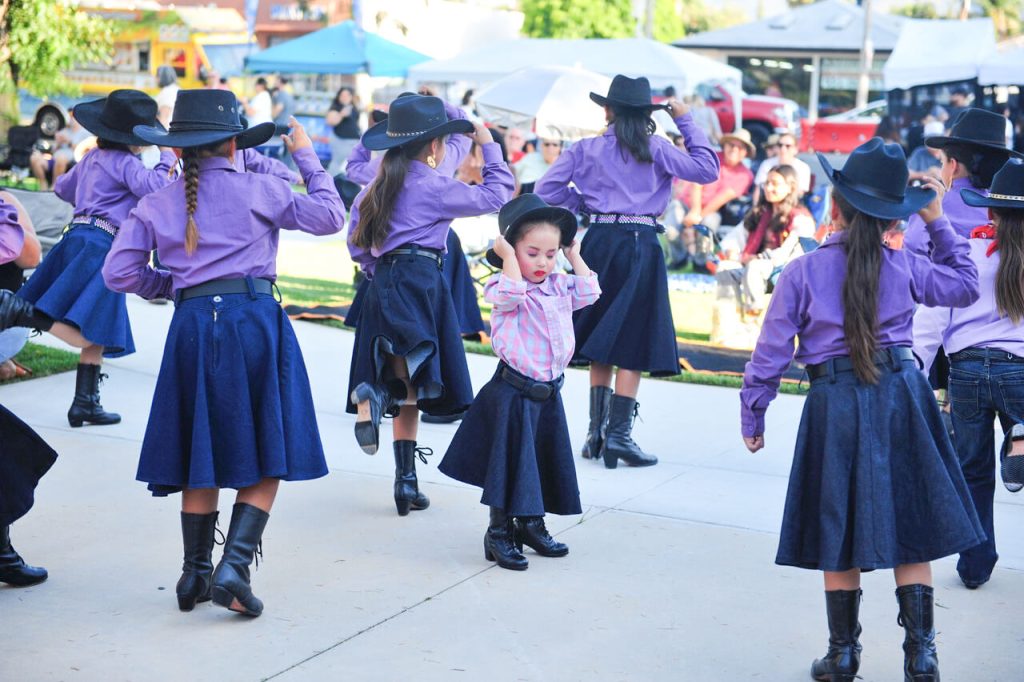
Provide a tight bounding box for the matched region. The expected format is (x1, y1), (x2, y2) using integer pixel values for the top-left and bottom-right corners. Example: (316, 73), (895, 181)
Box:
(572, 224), (679, 377)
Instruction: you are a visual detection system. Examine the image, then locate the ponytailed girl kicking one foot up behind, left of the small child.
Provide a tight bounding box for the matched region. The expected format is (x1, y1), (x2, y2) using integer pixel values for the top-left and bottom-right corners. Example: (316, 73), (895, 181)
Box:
(348, 95), (515, 516)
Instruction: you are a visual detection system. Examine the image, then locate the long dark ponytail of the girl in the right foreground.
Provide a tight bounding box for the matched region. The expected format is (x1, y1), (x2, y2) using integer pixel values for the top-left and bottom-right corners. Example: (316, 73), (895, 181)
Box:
(831, 189), (892, 384)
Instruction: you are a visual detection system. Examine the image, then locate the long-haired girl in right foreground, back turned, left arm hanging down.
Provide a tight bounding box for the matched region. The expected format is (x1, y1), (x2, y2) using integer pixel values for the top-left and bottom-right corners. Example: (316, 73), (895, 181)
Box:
(740, 137), (985, 682)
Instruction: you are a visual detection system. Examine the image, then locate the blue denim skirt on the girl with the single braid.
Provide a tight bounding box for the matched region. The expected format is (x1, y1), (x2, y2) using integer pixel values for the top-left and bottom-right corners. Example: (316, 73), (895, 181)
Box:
(136, 294), (328, 496)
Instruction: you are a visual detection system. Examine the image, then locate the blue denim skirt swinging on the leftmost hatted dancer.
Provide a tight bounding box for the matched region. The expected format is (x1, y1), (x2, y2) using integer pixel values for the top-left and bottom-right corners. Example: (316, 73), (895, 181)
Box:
(17, 225), (135, 357)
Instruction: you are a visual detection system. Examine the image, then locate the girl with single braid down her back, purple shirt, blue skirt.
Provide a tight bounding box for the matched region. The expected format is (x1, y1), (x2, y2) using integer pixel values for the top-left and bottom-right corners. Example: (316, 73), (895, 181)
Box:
(103, 90), (345, 616)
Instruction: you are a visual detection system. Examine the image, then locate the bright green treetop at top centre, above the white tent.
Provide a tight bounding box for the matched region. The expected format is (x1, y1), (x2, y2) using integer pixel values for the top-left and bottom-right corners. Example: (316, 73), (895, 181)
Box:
(521, 0), (637, 38)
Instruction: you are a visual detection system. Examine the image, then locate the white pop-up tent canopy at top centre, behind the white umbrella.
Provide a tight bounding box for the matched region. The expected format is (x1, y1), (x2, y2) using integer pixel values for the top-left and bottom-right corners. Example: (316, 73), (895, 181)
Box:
(409, 38), (741, 95)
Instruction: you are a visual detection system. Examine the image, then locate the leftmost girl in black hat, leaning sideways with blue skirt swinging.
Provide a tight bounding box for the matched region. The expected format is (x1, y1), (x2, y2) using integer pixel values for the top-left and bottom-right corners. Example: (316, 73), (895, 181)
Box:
(0, 90), (176, 426)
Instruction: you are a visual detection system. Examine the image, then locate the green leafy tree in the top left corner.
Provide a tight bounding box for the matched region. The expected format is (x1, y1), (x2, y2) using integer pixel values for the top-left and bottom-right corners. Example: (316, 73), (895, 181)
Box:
(0, 0), (114, 127)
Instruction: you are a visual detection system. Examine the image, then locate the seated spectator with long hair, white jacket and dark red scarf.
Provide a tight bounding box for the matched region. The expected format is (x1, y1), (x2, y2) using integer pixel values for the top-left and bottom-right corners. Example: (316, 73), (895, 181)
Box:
(715, 165), (814, 316)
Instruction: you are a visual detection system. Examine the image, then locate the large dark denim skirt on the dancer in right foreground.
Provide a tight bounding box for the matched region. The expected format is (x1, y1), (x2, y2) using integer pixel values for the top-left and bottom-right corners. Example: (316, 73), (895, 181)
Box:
(775, 360), (985, 571)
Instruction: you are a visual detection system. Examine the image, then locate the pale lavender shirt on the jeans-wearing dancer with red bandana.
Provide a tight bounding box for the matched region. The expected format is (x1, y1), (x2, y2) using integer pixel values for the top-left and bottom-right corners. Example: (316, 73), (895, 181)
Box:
(913, 239), (1024, 372)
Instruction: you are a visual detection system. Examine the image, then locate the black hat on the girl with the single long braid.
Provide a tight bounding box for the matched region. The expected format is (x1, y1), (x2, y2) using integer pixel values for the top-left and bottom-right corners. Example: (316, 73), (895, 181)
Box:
(135, 90), (274, 150)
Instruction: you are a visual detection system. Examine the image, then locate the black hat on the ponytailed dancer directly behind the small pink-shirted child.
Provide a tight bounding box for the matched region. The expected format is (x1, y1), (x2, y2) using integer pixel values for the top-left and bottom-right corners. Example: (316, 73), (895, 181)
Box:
(362, 95), (473, 152)
